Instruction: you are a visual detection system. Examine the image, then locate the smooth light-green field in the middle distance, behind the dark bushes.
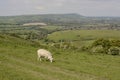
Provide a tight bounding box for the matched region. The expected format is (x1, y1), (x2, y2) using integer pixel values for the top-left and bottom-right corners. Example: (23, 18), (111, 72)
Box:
(48, 30), (120, 46)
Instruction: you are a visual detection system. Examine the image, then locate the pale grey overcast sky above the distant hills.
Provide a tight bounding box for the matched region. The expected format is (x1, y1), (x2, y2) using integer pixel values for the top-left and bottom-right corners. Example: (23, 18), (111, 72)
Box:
(0, 0), (120, 16)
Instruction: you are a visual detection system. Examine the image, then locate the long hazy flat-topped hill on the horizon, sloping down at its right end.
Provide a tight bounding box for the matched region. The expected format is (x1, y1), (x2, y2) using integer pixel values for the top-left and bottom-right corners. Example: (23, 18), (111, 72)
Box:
(0, 14), (85, 23)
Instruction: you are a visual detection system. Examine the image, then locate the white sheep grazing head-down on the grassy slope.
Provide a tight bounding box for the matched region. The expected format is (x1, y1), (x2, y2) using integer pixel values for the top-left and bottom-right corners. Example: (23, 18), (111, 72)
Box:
(37, 49), (53, 62)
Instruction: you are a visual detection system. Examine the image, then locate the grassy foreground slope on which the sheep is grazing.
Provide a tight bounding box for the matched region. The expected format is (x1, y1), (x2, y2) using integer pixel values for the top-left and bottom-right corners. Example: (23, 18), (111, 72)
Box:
(0, 34), (120, 80)
